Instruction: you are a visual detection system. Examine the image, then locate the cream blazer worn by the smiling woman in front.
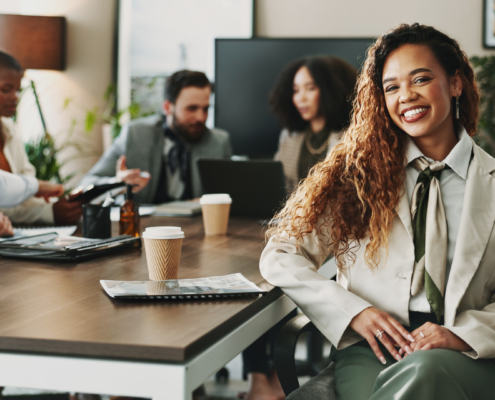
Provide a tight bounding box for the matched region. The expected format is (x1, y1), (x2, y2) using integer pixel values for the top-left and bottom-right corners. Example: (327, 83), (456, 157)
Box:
(260, 144), (495, 358)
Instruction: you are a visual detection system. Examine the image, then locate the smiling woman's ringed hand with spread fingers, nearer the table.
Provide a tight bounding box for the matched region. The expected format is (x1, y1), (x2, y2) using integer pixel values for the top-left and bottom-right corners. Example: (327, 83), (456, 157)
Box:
(350, 307), (419, 364)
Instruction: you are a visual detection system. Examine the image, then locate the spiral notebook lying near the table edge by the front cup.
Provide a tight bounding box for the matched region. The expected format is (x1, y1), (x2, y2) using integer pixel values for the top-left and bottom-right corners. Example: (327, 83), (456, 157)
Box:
(100, 273), (267, 300)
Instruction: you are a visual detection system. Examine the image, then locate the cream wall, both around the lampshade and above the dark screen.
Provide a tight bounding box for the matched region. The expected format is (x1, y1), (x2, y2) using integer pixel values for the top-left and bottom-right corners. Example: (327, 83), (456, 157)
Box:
(0, 0), (490, 188)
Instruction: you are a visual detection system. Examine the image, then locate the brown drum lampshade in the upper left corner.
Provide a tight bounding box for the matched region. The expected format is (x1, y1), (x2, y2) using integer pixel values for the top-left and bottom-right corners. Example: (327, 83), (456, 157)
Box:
(0, 14), (66, 70)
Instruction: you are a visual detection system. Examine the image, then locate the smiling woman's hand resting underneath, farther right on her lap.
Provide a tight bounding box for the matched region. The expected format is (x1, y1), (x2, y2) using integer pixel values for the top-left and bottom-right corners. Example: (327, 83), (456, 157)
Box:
(411, 322), (473, 351)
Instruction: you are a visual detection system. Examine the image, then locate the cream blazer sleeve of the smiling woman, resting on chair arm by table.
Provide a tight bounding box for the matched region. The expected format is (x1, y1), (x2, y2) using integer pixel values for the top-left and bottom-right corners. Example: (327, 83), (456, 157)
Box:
(260, 212), (371, 348)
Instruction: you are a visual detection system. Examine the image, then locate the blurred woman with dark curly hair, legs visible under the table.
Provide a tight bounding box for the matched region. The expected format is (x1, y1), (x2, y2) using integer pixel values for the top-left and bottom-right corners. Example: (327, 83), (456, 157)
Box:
(241, 56), (357, 400)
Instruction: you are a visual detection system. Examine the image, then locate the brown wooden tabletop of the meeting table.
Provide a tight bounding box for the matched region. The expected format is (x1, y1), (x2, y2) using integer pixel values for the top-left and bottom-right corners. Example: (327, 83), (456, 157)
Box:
(0, 217), (281, 361)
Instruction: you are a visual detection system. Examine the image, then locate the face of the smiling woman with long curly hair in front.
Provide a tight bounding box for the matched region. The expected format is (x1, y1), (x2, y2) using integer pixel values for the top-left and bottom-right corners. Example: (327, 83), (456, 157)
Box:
(382, 44), (462, 138)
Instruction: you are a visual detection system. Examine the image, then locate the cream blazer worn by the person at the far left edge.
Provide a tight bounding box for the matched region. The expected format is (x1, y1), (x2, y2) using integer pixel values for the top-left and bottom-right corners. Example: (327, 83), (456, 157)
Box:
(0, 117), (54, 224)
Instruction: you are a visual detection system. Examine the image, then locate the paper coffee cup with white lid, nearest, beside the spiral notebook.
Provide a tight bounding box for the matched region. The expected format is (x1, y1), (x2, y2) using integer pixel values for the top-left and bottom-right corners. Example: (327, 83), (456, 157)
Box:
(142, 226), (184, 281)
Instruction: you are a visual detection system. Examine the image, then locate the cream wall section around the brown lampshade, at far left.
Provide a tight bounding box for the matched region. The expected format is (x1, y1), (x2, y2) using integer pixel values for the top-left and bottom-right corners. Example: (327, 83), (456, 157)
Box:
(0, 0), (115, 186)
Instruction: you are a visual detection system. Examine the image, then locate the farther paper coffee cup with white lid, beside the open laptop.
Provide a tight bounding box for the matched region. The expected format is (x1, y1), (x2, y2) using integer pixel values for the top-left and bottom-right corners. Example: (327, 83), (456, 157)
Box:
(199, 193), (232, 235)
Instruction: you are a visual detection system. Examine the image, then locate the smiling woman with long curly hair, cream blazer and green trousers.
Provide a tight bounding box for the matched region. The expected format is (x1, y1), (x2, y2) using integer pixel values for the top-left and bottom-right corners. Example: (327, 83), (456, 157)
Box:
(261, 24), (495, 400)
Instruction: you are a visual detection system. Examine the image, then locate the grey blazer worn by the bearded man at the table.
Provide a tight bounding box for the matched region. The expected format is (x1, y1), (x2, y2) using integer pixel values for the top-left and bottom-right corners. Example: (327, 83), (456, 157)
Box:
(81, 115), (232, 204)
